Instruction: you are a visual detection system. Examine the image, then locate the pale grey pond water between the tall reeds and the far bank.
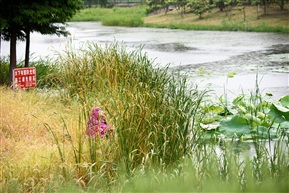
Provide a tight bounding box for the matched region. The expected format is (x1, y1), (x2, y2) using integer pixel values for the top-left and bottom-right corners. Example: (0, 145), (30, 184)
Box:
(1, 22), (289, 99)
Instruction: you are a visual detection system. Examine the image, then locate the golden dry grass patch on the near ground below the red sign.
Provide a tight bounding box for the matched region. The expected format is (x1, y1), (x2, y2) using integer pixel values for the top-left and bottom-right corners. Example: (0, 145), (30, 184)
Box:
(0, 87), (78, 177)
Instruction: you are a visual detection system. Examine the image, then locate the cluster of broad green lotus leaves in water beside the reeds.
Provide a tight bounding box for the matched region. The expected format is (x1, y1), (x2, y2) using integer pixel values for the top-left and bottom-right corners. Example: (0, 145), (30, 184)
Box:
(201, 82), (289, 140)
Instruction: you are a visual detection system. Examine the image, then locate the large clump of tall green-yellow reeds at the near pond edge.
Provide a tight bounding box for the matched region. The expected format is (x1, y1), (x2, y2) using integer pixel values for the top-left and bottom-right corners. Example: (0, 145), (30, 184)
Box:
(50, 44), (205, 172)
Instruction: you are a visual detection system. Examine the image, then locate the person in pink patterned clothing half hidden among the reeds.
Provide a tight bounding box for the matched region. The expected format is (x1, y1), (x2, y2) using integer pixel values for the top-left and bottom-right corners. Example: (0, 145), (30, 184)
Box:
(86, 107), (111, 138)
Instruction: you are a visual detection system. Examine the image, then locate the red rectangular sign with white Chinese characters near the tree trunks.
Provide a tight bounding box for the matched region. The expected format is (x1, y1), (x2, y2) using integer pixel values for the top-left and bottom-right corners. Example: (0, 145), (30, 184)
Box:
(13, 67), (36, 88)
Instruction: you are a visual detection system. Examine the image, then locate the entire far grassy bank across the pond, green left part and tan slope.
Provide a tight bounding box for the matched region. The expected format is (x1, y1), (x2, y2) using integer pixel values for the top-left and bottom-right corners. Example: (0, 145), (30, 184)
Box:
(72, 4), (289, 33)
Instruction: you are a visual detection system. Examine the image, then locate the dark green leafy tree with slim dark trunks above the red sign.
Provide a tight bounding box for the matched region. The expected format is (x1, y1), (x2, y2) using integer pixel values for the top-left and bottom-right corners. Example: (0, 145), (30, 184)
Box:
(0, 0), (82, 85)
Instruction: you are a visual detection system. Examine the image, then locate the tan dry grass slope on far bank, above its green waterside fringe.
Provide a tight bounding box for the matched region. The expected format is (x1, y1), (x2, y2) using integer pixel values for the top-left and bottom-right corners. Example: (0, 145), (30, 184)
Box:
(144, 5), (289, 28)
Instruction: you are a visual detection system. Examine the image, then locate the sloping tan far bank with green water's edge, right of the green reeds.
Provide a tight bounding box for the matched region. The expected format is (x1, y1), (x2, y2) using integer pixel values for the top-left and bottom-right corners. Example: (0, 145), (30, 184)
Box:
(144, 5), (289, 34)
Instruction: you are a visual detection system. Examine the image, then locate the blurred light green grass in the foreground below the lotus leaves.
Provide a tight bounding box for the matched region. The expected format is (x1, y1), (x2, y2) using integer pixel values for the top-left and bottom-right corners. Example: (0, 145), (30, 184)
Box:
(123, 136), (289, 192)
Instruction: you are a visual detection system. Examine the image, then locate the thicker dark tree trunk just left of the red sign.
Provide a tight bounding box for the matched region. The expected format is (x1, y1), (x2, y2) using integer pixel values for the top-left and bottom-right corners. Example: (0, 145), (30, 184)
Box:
(8, 31), (17, 86)
